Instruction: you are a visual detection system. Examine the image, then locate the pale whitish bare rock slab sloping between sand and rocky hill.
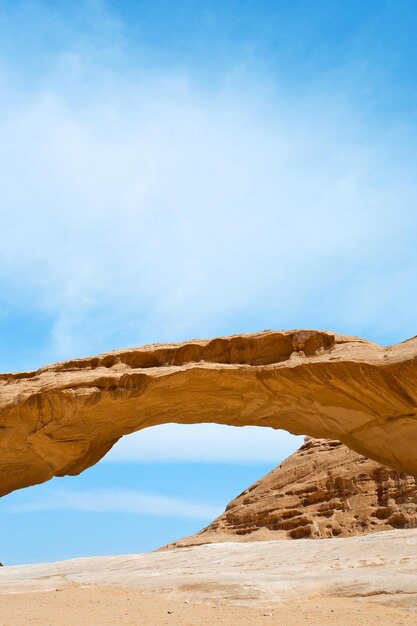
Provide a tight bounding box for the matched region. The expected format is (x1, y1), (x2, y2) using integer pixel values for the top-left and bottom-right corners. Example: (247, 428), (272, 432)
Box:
(0, 529), (417, 608)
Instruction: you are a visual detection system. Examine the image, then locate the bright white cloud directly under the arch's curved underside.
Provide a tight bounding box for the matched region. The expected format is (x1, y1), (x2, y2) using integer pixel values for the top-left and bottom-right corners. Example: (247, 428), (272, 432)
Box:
(103, 424), (303, 465)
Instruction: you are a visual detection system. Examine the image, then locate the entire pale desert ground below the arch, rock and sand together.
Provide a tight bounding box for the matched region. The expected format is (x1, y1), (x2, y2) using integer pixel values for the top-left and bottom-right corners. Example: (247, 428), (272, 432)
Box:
(0, 529), (417, 626)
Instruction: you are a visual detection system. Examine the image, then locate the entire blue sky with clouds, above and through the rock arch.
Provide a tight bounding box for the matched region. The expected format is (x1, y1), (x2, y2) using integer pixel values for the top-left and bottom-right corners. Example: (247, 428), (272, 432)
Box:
(0, 0), (417, 562)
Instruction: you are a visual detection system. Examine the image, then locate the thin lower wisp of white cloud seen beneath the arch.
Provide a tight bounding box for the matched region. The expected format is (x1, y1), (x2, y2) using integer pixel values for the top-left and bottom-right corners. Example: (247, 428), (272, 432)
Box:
(6, 489), (224, 520)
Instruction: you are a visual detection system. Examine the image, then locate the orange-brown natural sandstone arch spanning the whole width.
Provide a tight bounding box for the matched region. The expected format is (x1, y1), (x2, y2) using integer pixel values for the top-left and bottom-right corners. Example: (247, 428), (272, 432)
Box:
(0, 331), (417, 495)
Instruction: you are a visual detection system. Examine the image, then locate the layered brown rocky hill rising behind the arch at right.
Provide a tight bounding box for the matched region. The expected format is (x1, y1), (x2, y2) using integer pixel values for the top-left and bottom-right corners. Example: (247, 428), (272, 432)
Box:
(167, 438), (417, 547)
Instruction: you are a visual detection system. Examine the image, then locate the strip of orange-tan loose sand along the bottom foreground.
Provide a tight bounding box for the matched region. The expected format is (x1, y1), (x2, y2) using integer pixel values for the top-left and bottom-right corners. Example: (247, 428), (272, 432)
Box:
(0, 587), (417, 626)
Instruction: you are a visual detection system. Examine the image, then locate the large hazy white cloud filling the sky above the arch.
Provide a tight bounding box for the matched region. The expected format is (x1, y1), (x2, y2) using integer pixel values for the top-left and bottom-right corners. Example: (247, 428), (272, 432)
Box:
(0, 3), (417, 370)
